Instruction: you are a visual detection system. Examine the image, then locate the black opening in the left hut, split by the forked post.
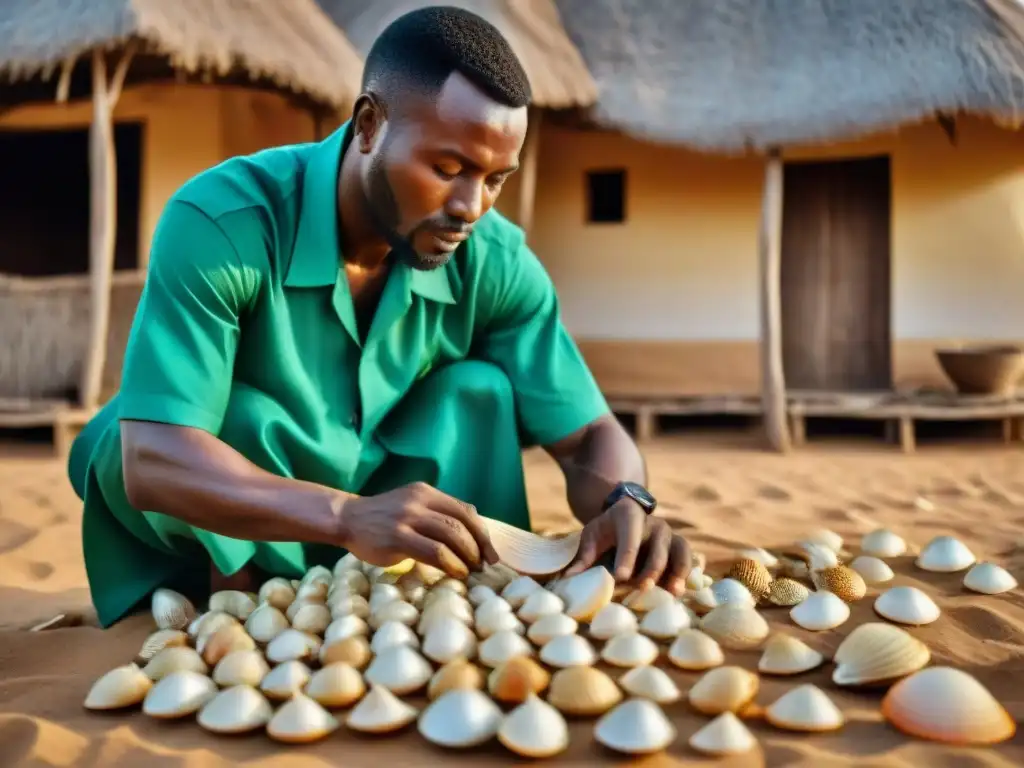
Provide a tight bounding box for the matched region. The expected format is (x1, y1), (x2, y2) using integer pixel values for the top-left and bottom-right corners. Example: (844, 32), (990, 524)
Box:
(0, 123), (143, 276)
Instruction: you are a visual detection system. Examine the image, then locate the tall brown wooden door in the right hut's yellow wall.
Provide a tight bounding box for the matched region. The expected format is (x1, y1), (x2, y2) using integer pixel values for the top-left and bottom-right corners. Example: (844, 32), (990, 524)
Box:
(781, 157), (892, 391)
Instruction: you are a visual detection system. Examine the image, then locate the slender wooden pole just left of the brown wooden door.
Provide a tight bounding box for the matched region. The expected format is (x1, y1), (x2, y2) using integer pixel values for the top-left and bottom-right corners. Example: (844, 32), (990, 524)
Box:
(758, 147), (792, 453)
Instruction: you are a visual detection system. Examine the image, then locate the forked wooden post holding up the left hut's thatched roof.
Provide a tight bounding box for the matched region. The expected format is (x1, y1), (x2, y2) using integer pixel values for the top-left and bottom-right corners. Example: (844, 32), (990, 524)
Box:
(79, 45), (134, 411)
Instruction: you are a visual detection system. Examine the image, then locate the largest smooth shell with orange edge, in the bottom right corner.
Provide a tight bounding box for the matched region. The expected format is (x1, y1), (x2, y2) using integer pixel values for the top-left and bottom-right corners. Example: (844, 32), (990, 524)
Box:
(882, 667), (1017, 745)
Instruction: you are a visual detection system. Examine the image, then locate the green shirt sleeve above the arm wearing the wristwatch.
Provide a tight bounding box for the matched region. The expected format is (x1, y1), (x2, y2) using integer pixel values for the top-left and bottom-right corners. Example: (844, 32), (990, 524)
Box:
(477, 242), (608, 445)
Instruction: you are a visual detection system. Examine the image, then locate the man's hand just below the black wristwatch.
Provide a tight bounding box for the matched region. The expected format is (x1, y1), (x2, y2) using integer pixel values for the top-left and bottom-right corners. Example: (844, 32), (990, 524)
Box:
(565, 498), (690, 595)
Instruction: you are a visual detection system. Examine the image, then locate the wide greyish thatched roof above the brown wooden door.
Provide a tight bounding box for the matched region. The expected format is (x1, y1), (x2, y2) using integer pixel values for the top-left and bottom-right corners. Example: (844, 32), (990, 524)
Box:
(555, 0), (1024, 151)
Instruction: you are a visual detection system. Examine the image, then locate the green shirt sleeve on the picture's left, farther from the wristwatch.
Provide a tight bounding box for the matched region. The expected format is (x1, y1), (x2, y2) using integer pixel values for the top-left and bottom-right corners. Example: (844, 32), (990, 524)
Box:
(118, 200), (254, 434)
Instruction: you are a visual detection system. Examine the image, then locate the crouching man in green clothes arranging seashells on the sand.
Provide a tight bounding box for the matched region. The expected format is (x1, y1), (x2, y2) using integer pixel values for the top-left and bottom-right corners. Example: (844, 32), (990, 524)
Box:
(69, 7), (689, 627)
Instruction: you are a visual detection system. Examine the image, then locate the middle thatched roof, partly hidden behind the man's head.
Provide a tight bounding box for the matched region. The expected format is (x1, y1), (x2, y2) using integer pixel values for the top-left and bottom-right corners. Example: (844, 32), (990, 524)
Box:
(318, 0), (597, 109)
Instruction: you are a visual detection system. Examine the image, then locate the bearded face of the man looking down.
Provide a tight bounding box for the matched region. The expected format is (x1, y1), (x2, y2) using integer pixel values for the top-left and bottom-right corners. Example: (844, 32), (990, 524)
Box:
(362, 73), (526, 269)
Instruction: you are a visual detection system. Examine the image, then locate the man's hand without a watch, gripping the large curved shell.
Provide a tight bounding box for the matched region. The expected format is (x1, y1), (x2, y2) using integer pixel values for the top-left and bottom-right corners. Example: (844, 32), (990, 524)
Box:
(339, 482), (498, 579)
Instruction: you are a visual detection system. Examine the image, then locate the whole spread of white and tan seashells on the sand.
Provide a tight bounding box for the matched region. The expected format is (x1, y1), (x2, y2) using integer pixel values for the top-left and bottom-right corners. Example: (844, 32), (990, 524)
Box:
(85, 530), (1017, 758)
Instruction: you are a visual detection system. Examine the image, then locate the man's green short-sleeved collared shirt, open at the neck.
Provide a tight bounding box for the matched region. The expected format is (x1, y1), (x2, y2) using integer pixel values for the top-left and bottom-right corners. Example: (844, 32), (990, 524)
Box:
(112, 123), (607, 493)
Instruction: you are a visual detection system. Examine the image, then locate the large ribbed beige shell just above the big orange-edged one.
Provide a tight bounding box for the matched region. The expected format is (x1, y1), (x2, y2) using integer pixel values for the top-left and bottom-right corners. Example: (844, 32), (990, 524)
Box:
(833, 622), (931, 686)
